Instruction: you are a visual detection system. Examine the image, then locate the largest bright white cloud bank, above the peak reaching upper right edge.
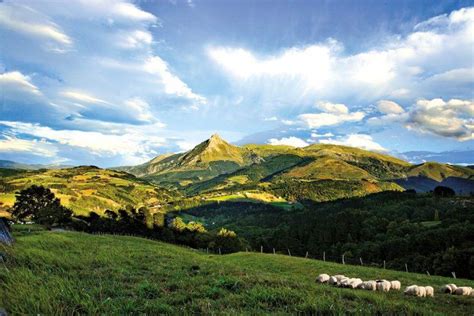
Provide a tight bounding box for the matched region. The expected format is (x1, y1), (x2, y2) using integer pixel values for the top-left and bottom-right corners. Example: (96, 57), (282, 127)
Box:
(208, 8), (474, 107)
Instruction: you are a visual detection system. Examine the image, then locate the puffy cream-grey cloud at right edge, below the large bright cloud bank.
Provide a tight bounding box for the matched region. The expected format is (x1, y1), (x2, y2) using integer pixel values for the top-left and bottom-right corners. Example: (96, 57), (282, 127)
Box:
(406, 99), (474, 141)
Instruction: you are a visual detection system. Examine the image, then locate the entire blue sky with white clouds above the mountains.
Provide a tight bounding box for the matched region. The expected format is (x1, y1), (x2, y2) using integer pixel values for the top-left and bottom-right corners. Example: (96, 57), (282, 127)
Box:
(0, 0), (474, 167)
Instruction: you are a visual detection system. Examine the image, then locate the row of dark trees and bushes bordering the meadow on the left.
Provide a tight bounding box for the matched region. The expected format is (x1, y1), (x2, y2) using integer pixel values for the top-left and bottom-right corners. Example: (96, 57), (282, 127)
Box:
(11, 185), (245, 253)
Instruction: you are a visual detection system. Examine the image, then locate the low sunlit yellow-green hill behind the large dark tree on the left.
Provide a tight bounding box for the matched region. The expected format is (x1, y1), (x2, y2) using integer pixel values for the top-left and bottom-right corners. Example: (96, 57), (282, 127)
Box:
(0, 166), (176, 215)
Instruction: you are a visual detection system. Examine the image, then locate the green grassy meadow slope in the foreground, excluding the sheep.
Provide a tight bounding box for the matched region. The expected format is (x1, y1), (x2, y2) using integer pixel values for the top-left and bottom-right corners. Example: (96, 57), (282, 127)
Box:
(0, 227), (474, 315)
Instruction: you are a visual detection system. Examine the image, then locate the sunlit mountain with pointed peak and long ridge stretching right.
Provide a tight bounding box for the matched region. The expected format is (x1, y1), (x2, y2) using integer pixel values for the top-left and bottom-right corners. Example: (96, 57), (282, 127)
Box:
(121, 135), (474, 201)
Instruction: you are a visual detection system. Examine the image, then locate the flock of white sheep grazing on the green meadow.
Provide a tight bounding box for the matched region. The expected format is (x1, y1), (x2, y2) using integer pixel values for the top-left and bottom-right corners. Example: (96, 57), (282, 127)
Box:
(316, 273), (474, 297)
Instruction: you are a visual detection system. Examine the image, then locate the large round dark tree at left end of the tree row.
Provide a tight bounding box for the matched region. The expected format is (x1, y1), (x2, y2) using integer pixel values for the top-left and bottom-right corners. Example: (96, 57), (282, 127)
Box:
(12, 185), (72, 227)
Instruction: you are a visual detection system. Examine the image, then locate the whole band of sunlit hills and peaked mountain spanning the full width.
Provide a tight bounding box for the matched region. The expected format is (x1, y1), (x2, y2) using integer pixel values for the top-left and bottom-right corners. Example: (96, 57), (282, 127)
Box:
(0, 135), (474, 214)
